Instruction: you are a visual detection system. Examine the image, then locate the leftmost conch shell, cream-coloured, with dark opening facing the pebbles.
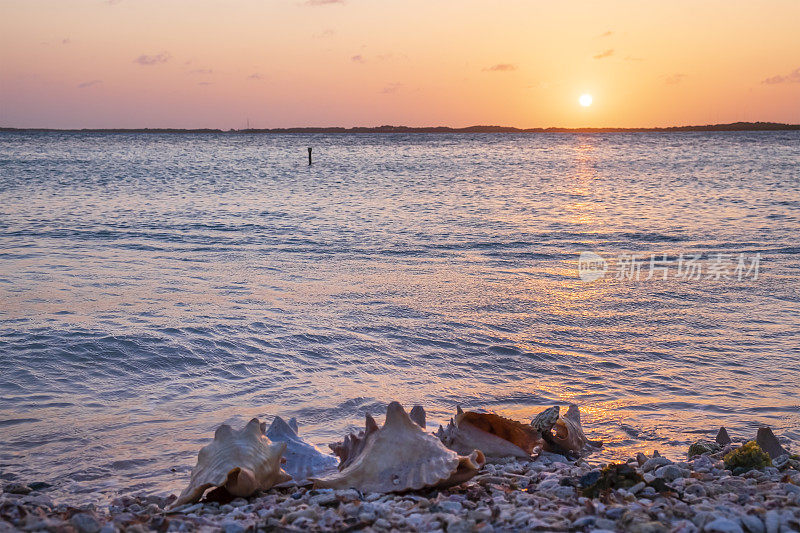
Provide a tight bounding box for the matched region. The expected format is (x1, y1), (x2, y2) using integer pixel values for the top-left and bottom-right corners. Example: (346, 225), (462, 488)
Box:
(171, 418), (291, 508)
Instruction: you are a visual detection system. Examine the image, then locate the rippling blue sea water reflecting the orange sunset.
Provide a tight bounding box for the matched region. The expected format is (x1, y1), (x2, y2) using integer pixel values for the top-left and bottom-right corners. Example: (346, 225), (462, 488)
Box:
(0, 132), (800, 501)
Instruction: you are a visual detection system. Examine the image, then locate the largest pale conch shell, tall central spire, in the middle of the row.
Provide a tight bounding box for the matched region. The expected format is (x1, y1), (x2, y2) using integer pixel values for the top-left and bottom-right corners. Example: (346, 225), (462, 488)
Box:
(314, 402), (485, 492)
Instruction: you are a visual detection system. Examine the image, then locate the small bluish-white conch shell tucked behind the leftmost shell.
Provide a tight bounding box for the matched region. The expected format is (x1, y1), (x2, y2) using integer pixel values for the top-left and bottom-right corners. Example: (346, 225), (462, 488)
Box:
(267, 416), (339, 482)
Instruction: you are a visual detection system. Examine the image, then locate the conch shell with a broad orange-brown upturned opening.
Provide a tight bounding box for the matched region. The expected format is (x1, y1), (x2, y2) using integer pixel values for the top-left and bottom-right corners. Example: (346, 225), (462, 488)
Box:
(436, 407), (543, 459)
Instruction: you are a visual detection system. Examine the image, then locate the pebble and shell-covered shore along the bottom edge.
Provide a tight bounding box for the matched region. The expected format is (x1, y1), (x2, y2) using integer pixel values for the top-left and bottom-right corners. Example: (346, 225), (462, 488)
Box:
(0, 452), (800, 533)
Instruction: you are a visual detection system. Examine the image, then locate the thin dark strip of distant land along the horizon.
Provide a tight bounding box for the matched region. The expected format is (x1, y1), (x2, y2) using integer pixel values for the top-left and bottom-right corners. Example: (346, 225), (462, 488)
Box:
(0, 122), (800, 134)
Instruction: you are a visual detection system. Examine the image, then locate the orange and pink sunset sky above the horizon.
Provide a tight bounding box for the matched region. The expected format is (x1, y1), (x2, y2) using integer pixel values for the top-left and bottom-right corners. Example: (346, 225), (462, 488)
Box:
(0, 0), (800, 128)
